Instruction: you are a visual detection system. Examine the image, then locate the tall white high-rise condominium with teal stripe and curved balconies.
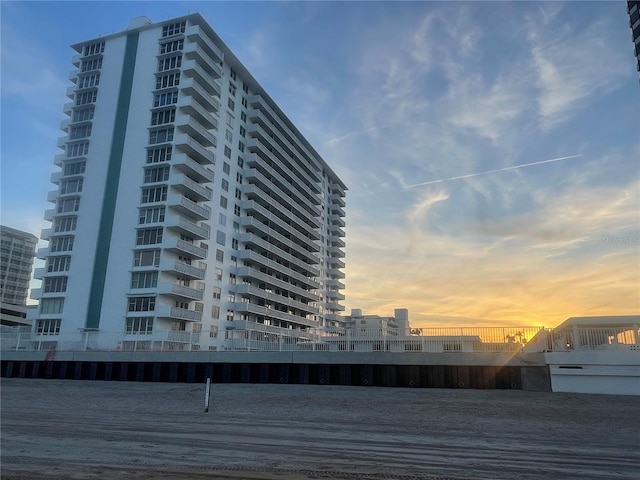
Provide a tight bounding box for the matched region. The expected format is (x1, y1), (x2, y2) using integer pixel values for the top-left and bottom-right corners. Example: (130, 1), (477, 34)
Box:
(34, 14), (346, 350)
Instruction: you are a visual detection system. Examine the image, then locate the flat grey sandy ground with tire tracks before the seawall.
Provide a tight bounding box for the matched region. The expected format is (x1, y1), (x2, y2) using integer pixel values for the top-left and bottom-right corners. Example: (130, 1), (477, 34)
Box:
(1, 378), (640, 480)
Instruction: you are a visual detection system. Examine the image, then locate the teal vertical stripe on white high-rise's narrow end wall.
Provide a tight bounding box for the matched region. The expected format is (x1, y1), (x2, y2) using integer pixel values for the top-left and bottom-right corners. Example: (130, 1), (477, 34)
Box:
(85, 33), (139, 329)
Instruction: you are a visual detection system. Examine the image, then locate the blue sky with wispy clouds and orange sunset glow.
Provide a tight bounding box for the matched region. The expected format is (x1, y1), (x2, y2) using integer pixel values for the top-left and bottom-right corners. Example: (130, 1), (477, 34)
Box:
(1, 1), (640, 326)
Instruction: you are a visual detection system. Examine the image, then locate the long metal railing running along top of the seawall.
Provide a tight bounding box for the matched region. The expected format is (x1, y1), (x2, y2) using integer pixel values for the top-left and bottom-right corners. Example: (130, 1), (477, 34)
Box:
(0, 321), (640, 354)
